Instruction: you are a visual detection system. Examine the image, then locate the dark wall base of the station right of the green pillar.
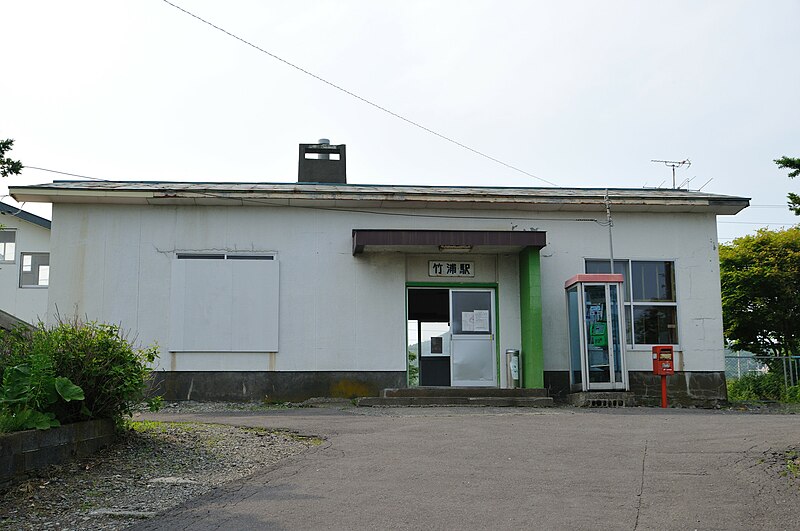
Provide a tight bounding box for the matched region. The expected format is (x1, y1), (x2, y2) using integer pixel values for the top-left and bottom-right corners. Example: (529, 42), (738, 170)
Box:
(544, 371), (728, 407)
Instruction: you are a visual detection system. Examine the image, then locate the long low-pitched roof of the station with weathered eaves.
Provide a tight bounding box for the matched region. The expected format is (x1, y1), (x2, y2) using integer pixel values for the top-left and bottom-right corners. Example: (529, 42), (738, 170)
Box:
(10, 181), (749, 214)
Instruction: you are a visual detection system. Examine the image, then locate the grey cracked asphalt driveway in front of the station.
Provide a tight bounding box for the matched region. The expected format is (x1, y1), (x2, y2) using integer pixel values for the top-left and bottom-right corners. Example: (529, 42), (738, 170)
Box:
(136, 408), (800, 530)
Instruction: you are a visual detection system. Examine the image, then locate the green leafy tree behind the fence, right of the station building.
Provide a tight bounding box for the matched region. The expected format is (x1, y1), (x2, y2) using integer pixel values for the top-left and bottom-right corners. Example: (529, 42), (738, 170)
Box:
(719, 226), (800, 362)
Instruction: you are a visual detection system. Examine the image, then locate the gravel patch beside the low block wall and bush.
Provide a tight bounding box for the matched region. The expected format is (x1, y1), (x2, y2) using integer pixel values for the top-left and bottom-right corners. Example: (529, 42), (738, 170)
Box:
(0, 420), (321, 531)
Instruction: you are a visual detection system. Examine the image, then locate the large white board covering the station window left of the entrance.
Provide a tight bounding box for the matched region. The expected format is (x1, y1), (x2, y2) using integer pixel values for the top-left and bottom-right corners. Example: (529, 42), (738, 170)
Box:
(169, 255), (279, 352)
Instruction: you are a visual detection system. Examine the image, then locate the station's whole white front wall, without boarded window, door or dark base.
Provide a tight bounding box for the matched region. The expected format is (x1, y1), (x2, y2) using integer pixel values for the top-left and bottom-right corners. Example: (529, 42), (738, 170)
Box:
(49, 204), (724, 374)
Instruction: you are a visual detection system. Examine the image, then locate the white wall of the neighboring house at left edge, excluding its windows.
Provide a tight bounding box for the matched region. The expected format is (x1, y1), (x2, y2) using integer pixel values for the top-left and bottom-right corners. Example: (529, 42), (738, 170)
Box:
(0, 215), (52, 324)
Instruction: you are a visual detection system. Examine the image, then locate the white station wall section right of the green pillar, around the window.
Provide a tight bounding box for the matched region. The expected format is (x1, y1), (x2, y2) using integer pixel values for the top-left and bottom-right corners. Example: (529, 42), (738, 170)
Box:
(541, 213), (725, 371)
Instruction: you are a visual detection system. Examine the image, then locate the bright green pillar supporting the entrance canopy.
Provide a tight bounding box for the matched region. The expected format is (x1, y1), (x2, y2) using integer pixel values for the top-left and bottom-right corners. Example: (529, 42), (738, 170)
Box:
(519, 247), (544, 388)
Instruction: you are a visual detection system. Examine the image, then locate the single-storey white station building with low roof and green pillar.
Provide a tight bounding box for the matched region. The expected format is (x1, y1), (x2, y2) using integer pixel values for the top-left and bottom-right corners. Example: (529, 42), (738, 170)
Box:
(11, 145), (748, 401)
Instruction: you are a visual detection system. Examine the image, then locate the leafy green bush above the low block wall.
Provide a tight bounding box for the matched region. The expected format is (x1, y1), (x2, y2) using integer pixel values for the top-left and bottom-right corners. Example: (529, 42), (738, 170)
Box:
(0, 321), (158, 431)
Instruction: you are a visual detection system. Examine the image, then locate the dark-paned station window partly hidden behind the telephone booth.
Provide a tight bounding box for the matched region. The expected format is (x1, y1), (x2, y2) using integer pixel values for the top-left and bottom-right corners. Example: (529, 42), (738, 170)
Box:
(586, 260), (678, 346)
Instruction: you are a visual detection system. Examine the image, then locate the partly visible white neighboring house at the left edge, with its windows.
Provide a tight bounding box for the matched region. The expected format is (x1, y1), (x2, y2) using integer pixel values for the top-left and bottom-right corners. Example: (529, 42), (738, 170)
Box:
(0, 203), (50, 324)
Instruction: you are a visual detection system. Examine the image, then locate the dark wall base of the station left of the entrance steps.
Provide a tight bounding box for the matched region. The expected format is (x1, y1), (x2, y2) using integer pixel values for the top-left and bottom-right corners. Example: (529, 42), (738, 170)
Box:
(151, 371), (406, 402)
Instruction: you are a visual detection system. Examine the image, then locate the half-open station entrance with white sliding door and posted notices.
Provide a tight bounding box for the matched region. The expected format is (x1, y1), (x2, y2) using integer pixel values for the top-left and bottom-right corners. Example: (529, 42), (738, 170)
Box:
(408, 288), (497, 387)
